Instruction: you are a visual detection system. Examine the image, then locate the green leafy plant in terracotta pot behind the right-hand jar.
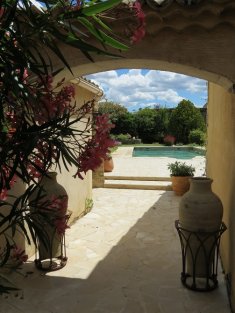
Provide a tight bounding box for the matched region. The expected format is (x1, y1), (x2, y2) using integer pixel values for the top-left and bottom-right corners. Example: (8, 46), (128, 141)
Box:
(168, 161), (195, 196)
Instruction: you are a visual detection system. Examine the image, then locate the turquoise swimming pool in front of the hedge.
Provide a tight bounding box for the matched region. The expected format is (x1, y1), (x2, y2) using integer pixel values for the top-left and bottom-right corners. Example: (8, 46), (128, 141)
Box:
(132, 147), (205, 160)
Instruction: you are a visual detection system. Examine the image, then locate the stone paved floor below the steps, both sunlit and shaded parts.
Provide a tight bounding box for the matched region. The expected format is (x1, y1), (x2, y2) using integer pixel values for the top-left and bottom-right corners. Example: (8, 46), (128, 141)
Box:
(0, 147), (230, 313)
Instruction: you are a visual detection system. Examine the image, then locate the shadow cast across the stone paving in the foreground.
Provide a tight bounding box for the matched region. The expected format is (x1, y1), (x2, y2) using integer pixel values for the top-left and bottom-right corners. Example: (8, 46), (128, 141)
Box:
(0, 191), (229, 313)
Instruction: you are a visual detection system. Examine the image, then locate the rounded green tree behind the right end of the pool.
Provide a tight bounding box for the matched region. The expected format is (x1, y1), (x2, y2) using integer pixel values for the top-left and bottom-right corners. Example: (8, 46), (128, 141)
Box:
(169, 100), (206, 144)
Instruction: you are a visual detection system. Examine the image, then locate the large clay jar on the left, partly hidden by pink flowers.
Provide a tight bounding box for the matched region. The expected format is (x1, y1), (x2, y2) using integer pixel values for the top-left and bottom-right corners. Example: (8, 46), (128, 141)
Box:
(30, 172), (68, 260)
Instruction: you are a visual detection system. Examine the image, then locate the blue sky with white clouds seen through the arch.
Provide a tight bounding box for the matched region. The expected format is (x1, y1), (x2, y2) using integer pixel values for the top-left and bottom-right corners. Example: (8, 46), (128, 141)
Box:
(86, 69), (207, 111)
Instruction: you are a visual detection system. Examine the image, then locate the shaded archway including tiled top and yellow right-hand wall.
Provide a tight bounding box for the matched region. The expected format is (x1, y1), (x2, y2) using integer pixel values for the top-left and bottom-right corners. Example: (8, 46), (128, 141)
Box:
(54, 0), (235, 308)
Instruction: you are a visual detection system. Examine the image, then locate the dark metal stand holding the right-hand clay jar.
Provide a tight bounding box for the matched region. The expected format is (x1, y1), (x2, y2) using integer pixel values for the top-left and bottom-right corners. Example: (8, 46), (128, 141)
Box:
(175, 220), (227, 291)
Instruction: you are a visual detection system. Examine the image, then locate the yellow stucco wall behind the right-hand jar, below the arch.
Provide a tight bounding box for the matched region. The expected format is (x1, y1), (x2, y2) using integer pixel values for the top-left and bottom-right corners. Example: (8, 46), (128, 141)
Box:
(207, 83), (235, 309)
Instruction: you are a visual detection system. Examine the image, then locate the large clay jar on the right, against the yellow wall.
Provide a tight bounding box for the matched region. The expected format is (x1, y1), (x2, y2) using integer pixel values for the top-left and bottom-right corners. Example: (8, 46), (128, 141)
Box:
(179, 177), (223, 277)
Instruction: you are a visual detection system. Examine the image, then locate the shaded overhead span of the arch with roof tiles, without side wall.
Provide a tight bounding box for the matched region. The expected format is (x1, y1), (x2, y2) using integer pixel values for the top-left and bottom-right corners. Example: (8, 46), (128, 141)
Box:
(54, 0), (235, 92)
